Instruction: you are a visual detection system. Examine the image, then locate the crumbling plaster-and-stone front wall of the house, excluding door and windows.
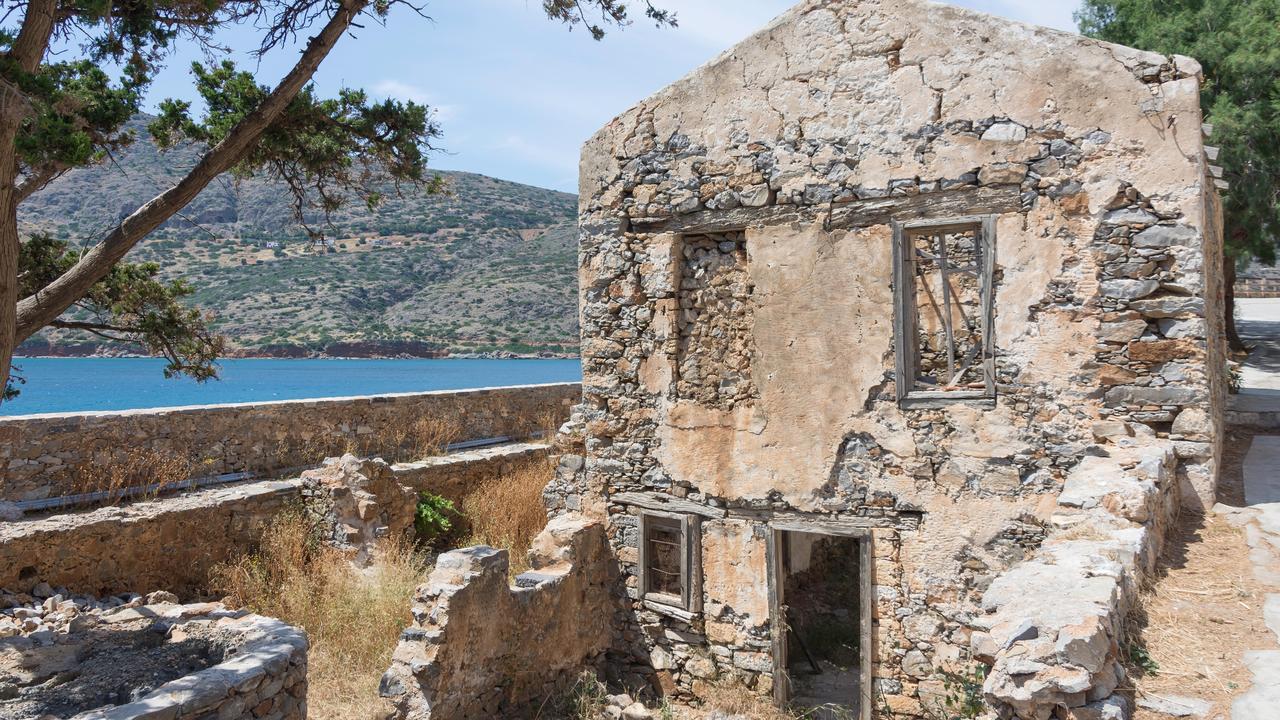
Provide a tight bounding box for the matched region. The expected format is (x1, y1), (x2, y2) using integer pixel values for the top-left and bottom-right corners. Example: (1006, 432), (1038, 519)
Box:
(580, 0), (1221, 712)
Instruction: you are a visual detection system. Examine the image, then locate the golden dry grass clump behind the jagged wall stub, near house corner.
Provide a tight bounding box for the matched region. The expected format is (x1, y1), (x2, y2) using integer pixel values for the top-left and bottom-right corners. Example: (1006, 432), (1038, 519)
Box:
(458, 459), (554, 574)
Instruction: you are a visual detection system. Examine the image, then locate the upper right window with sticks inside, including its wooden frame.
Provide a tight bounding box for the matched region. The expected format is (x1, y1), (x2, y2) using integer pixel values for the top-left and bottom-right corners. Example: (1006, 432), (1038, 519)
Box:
(893, 218), (996, 404)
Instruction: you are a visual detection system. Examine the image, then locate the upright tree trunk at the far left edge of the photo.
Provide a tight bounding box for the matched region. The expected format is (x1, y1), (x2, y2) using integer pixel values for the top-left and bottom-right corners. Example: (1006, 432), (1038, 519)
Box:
(0, 0), (58, 397)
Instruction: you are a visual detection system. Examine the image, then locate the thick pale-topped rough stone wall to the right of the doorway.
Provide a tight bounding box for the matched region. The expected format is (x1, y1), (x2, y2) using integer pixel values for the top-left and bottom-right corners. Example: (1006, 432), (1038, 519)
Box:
(970, 438), (1172, 720)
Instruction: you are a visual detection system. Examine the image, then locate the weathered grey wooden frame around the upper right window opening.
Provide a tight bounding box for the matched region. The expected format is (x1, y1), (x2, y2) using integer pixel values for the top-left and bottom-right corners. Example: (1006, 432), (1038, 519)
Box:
(891, 215), (996, 409)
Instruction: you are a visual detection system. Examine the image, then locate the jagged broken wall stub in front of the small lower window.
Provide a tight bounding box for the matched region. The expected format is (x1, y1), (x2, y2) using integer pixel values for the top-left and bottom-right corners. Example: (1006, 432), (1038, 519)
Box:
(380, 515), (613, 720)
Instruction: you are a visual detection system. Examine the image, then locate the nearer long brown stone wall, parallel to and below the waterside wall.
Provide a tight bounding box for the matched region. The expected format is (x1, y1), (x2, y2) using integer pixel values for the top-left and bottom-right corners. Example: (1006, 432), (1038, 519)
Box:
(0, 443), (549, 594)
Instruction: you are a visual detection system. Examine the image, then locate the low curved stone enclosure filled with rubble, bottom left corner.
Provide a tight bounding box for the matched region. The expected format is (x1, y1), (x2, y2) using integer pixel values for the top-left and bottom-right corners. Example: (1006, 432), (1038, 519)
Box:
(0, 583), (307, 720)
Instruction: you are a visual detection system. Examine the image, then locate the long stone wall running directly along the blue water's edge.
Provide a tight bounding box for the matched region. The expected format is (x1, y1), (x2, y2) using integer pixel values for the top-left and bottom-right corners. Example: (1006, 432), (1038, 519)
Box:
(0, 383), (581, 501)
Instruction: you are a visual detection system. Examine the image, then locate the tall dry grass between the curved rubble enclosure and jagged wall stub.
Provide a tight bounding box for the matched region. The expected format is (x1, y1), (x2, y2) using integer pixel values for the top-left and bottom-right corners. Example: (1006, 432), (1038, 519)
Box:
(215, 512), (429, 720)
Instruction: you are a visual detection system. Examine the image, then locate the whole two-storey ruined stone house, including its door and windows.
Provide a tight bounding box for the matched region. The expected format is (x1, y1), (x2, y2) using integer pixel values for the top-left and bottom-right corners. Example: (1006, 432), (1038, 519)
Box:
(568, 0), (1225, 717)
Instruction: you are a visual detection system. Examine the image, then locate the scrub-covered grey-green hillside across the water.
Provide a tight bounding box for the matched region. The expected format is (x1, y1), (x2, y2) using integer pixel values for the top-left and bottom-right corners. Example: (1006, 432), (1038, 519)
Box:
(22, 118), (577, 356)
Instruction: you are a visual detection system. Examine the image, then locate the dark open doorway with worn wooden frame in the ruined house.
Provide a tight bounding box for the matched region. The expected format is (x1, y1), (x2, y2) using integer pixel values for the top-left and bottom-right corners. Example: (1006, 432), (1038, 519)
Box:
(773, 520), (870, 720)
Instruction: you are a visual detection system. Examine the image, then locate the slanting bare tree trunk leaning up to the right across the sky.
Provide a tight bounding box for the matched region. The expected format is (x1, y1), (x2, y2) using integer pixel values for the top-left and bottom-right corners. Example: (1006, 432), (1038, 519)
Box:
(0, 0), (369, 386)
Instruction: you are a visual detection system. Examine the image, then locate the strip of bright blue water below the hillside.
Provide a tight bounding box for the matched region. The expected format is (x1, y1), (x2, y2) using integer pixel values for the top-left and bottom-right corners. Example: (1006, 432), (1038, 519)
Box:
(0, 357), (582, 415)
